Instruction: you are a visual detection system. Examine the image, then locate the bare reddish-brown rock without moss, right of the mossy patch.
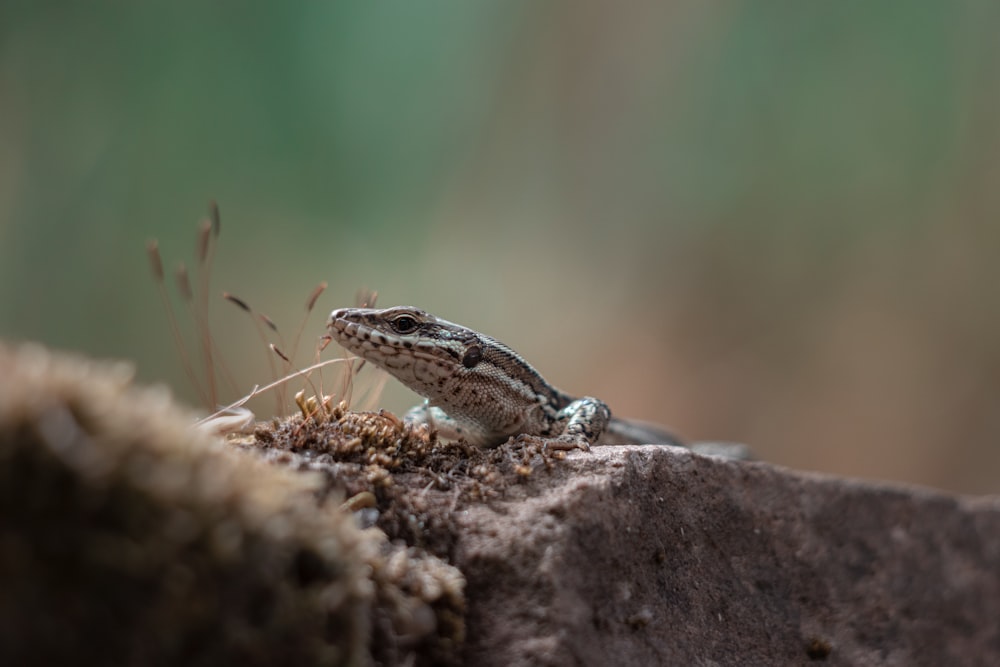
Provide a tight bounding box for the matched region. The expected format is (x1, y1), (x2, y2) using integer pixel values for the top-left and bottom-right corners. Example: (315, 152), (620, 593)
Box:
(454, 447), (1000, 665)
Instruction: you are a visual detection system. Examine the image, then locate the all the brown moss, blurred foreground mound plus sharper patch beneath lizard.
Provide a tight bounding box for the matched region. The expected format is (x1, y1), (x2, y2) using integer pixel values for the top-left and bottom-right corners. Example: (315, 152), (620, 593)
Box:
(0, 344), (580, 665)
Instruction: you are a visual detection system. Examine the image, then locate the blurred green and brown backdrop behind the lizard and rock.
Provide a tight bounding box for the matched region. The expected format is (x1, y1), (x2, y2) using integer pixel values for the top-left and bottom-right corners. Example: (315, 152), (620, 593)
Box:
(0, 0), (1000, 492)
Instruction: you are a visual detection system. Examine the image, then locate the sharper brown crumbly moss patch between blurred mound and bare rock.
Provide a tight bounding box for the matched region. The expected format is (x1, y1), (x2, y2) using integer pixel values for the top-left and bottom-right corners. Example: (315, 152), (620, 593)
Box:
(236, 401), (564, 665)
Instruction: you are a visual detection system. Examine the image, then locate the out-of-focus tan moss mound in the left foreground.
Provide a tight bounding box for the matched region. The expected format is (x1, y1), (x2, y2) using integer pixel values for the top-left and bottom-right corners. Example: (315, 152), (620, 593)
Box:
(0, 346), (376, 665)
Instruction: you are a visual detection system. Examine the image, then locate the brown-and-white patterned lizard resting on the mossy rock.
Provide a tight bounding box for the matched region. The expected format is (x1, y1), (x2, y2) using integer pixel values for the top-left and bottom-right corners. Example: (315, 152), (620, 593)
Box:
(327, 306), (743, 458)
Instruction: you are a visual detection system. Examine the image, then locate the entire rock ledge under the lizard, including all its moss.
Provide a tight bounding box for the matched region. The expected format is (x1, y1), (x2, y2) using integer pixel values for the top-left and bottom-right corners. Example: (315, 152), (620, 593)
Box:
(0, 345), (1000, 665)
